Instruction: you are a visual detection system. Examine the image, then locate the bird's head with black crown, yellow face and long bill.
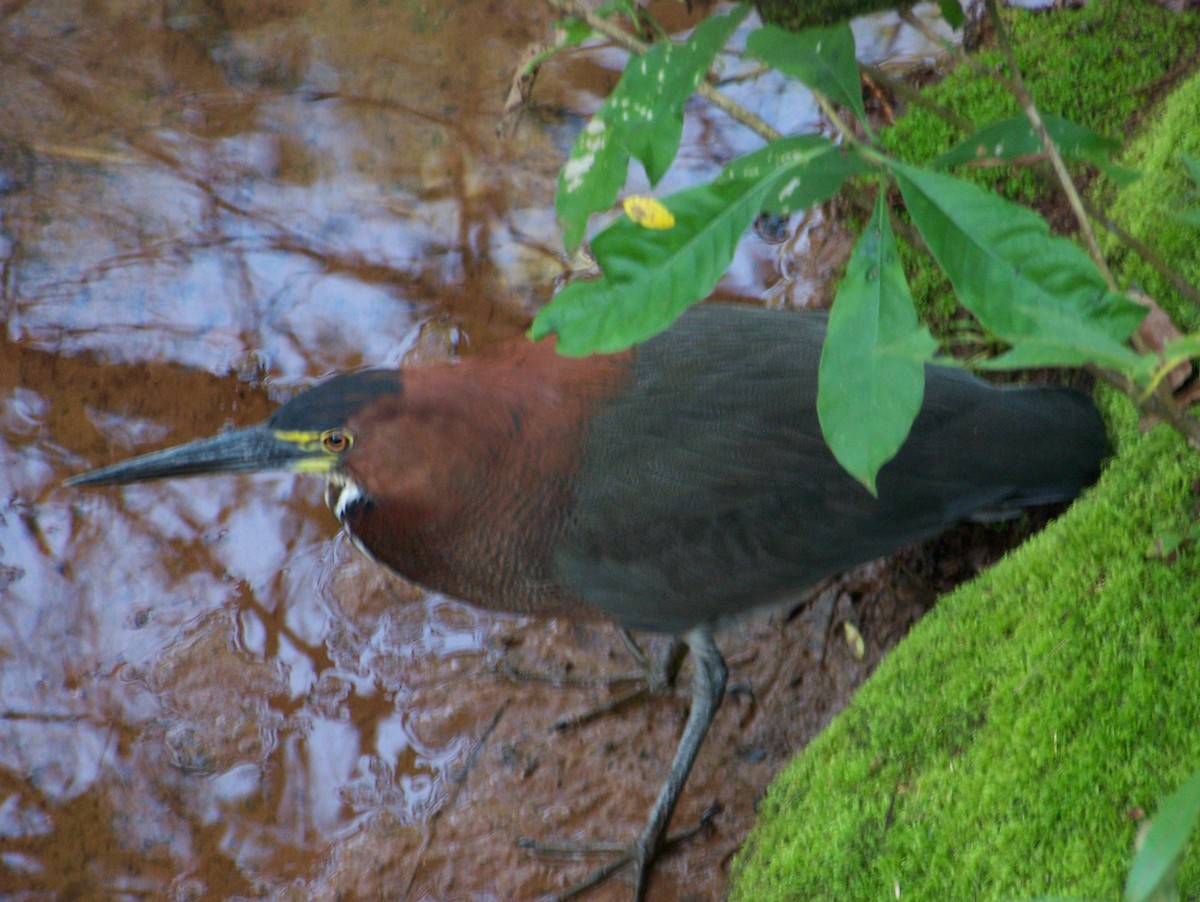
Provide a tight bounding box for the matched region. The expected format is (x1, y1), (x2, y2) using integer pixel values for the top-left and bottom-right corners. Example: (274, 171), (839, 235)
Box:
(66, 369), (401, 486)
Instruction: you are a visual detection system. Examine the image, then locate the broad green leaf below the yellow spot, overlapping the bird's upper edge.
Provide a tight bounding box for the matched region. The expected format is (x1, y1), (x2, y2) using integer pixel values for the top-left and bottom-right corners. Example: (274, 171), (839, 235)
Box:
(529, 172), (778, 356)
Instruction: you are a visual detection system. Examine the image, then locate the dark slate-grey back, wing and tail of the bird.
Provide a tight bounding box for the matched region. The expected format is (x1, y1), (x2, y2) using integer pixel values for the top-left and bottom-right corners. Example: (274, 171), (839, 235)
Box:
(553, 305), (1106, 632)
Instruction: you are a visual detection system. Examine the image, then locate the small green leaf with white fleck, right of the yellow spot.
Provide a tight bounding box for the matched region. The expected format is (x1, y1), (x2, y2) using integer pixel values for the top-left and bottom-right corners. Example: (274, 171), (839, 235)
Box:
(718, 134), (870, 214)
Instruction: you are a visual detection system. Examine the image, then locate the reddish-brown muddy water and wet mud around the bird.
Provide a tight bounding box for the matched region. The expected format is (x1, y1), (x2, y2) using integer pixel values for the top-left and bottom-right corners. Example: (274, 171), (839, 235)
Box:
(0, 0), (984, 900)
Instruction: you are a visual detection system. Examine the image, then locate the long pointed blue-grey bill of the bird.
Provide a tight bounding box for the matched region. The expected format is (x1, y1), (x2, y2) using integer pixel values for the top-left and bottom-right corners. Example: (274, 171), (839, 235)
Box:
(65, 425), (320, 486)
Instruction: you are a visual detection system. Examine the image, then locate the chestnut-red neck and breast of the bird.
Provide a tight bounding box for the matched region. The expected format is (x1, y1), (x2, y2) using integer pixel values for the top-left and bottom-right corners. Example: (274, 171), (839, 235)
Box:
(314, 342), (630, 618)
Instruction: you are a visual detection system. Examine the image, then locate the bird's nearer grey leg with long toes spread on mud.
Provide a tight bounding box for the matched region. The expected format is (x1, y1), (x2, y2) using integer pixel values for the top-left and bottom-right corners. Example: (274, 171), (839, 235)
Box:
(520, 624), (727, 902)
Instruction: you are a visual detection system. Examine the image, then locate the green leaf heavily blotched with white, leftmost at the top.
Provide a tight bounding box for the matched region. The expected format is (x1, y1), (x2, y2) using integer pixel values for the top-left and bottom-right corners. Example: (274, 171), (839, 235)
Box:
(554, 4), (750, 249)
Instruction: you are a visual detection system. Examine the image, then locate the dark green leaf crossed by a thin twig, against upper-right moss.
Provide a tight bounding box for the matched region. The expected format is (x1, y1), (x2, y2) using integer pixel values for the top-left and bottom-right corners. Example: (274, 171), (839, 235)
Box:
(931, 114), (1139, 186)
